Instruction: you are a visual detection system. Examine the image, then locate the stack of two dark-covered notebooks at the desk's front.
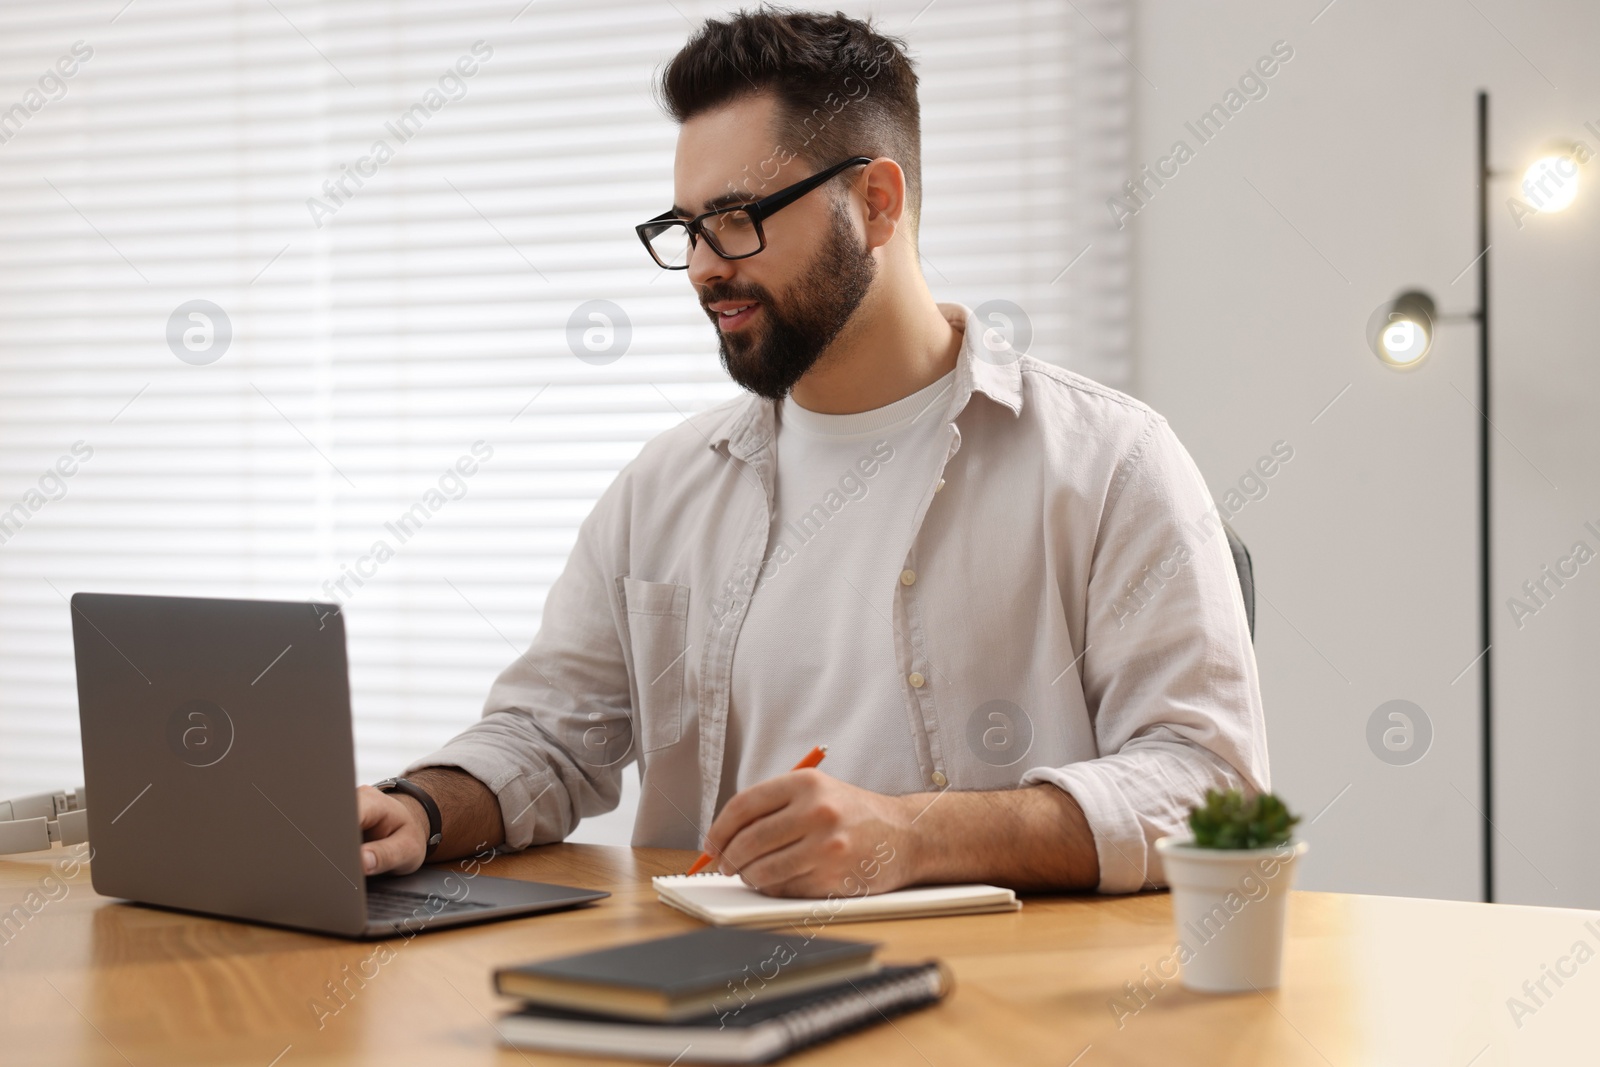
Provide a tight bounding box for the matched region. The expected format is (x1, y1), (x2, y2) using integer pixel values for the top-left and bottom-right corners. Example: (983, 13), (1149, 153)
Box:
(494, 926), (952, 1064)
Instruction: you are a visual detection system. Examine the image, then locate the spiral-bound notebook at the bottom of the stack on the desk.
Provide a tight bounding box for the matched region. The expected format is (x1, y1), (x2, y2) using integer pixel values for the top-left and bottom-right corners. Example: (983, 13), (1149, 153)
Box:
(496, 961), (954, 1064)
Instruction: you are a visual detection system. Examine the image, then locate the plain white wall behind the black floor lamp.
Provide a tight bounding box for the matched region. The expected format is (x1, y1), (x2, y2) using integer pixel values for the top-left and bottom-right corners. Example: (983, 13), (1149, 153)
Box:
(1126, 0), (1600, 907)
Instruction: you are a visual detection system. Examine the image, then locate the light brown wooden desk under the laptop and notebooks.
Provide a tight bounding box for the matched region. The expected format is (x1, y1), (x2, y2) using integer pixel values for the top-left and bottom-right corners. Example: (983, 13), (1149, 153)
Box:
(0, 845), (1600, 1067)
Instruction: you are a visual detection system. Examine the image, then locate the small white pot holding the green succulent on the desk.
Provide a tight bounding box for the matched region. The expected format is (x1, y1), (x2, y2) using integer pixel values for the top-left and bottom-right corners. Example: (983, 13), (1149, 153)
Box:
(1155, 837), (1310, 993)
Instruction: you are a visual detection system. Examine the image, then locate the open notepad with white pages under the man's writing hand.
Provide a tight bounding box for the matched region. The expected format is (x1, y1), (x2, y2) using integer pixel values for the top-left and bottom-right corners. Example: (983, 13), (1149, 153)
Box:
(651, 873), (1022, 926)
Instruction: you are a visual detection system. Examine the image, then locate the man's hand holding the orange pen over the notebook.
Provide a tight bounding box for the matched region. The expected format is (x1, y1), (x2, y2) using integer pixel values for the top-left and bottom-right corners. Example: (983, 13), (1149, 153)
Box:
(706, 769), (926, 897)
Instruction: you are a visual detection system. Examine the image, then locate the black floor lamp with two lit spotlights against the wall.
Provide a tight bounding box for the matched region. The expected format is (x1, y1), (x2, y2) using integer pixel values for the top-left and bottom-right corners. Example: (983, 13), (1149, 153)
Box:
(1368, 91), (1589, 902)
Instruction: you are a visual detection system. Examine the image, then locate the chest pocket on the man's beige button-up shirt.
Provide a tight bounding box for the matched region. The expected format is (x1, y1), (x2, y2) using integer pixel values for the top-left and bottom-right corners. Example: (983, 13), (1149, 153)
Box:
(618, 576), (690, 752)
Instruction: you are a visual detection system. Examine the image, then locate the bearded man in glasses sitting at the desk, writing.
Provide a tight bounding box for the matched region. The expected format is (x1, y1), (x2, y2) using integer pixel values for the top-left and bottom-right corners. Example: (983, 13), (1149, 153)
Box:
(360, 10), (1269, 896)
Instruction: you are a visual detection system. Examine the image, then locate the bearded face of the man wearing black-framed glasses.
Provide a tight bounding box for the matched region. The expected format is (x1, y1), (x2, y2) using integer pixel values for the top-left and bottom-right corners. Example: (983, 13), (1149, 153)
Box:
(674, 94), (877, 400)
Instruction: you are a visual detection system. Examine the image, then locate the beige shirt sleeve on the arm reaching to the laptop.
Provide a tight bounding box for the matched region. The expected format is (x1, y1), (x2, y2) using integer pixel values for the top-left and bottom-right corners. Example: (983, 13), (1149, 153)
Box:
(406, 472), (635, 848)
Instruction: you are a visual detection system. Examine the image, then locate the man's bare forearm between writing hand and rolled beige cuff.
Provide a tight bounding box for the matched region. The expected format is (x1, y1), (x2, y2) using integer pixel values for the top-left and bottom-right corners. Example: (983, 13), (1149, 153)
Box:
(901, 785), (1099, 891)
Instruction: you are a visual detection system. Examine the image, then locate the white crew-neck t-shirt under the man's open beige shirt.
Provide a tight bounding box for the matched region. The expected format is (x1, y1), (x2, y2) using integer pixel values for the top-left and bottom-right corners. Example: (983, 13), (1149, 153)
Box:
(718, 371), (955, 809)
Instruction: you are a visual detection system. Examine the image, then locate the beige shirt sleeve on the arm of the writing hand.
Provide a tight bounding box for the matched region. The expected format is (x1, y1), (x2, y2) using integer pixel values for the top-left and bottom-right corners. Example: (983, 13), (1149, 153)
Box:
(1022, 413), (1270, 893)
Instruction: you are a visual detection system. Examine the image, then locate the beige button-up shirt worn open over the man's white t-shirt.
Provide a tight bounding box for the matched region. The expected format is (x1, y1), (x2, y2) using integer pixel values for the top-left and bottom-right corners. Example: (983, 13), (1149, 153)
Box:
(408, 304), (1269, 893)
